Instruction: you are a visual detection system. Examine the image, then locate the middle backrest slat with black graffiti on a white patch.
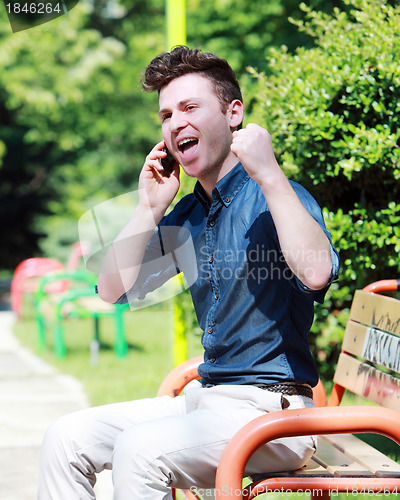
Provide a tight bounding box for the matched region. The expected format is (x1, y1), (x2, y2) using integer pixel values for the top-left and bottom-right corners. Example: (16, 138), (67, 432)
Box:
(342, 321), (400, 373)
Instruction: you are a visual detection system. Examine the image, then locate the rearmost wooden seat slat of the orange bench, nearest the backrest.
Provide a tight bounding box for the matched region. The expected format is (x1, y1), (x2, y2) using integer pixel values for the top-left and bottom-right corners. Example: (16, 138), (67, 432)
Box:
(320, 434), (400, 477)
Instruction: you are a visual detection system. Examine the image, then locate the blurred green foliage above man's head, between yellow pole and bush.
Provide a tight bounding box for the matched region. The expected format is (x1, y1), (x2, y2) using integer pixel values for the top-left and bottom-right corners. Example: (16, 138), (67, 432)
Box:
(187, 0), (341, 77)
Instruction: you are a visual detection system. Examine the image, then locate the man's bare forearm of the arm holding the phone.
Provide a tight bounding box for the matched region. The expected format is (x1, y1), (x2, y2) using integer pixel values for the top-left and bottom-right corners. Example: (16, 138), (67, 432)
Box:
(98, 205), (163, 303)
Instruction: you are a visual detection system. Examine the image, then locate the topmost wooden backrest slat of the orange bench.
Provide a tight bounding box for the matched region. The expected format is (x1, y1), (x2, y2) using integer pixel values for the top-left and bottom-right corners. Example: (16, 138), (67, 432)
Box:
(350, 290), (400, 335)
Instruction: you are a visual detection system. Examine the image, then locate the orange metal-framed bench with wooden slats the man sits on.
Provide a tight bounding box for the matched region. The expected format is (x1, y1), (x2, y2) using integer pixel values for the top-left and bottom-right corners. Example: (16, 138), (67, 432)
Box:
(159, 280), (400, 500)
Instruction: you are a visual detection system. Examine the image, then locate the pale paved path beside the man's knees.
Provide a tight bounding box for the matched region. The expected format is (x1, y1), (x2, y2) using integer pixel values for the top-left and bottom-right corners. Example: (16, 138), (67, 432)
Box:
(0, 311), (112, 500)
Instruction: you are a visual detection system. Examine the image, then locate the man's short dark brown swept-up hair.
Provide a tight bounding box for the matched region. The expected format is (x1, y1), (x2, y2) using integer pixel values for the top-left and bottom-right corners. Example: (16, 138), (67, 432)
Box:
(142, 45), (243, 112)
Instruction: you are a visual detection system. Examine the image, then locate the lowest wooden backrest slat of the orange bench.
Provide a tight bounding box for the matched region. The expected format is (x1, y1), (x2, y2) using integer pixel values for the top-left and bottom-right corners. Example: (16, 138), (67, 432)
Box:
(334, 353), (400, 410)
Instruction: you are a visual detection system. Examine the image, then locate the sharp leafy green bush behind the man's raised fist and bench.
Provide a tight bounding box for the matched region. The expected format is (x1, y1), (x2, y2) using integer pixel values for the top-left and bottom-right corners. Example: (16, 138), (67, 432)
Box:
(245, 0), (400, 379)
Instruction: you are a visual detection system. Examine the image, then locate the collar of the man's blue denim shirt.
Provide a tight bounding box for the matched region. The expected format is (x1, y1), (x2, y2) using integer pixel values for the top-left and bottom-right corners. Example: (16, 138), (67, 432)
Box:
(194, 162), (250, 207)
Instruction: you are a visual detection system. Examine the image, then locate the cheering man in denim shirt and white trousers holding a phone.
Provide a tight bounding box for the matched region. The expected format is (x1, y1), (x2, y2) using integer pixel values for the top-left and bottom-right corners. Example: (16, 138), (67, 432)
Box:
(39, 47), (338, 500)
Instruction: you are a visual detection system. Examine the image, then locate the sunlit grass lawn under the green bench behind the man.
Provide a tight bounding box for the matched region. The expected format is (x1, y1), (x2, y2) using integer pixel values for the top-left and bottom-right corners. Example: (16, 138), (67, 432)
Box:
(14, 302), (201, 405)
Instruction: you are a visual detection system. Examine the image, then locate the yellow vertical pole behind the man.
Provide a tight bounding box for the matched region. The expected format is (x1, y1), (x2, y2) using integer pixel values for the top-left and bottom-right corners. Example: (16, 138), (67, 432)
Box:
(166, 0), (188, 366)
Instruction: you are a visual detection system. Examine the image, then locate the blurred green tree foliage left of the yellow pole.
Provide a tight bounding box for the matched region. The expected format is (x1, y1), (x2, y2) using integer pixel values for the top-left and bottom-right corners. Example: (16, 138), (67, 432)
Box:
(0, 2), (163, 267)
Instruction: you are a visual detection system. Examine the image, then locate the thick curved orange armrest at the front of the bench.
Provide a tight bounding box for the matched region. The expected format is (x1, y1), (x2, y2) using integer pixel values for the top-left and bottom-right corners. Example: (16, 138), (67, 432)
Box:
(215, 406), (400, 500)
